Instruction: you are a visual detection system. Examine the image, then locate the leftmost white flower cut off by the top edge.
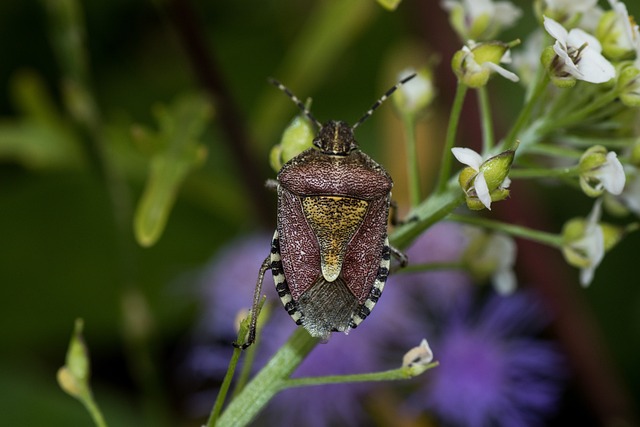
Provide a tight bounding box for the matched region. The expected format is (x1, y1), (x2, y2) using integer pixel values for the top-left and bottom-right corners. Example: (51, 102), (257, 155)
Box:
(440, 0), (522, 40)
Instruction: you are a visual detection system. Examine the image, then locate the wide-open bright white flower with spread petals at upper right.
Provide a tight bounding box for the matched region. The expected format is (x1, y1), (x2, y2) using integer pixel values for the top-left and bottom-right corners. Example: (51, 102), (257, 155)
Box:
(544, 16), (616, 83)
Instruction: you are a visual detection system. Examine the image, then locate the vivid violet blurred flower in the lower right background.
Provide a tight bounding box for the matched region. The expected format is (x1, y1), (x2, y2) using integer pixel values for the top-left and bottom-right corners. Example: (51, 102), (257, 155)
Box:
(411, 291), (566, 427)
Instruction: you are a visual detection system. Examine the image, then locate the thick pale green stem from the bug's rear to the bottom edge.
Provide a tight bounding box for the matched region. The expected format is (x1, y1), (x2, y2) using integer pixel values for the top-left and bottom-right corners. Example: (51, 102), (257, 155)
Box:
(216, 328), (320, 427)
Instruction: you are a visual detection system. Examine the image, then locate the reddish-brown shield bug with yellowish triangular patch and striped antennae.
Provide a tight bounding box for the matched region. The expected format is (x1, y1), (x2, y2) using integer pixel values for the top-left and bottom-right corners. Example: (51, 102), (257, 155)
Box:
(235, 74), (415, 348)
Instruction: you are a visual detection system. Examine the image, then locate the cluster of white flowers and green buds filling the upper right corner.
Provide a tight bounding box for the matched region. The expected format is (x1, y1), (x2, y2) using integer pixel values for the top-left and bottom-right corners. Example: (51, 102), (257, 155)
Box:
(444, 0), (640, 284)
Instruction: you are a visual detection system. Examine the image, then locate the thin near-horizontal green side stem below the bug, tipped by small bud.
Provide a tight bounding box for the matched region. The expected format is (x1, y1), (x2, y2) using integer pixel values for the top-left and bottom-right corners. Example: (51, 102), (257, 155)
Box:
(284, 362), (438, 388)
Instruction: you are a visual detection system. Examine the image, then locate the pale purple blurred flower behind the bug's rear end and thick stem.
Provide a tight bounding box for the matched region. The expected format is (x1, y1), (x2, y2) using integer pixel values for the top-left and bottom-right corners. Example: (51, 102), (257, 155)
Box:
(179, 235), (417, 427)
